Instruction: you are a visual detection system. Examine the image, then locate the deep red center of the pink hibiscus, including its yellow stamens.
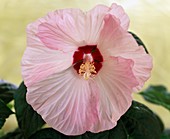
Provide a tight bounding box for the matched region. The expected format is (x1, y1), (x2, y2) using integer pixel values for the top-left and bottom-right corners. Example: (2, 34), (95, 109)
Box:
(73, 45), (103, 80)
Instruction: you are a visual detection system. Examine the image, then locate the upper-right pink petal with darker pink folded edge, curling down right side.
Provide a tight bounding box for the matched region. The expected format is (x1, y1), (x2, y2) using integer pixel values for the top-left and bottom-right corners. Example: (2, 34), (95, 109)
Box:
(98, 15), (152, 91)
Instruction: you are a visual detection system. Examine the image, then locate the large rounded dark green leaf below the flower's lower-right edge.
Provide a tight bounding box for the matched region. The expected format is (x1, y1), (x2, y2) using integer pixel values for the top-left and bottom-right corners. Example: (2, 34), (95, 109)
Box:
(121, 101), (163, 139)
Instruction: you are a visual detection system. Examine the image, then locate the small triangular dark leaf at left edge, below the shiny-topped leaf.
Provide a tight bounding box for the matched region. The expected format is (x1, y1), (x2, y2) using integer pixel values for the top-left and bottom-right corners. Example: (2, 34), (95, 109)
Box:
(0, 99), (13, 129)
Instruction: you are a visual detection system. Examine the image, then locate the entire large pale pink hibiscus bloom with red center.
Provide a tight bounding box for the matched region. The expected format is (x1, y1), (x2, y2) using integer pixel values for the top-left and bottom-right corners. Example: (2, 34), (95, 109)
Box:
(22, 4), (152, 135)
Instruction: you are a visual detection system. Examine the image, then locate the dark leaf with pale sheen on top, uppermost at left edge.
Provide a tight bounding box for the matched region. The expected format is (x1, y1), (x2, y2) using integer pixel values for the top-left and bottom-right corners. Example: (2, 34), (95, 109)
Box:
(0, 80), (17, 104)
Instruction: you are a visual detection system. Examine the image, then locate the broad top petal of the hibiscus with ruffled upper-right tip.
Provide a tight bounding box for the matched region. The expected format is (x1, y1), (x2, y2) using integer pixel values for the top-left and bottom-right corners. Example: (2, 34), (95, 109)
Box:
(27, 4), (128, 52)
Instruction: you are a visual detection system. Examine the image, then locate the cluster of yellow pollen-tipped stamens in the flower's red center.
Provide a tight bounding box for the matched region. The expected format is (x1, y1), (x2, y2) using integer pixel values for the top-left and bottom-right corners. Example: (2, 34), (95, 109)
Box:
(79, 61), (97, 80)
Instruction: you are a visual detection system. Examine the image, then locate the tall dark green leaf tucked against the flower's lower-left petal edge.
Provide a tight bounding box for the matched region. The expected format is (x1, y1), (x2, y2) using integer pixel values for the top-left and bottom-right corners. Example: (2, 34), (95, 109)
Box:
(14, 82), (45, 138)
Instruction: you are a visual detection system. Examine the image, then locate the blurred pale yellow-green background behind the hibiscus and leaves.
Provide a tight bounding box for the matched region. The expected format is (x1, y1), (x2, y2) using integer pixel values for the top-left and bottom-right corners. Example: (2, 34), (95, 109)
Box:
(0, 0), (170, 134)
